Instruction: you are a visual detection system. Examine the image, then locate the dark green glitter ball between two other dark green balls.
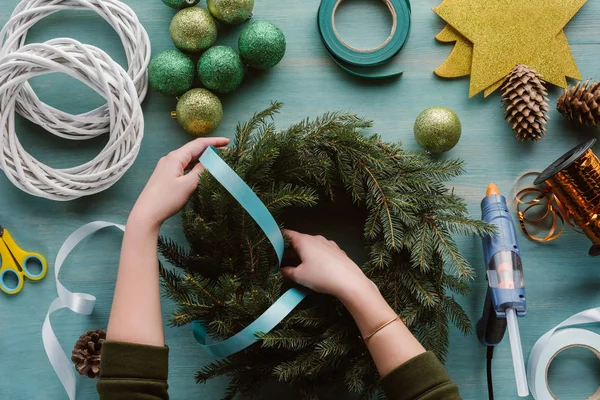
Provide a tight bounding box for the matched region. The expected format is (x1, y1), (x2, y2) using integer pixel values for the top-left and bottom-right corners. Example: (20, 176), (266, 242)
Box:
(198, 46), (244, 93)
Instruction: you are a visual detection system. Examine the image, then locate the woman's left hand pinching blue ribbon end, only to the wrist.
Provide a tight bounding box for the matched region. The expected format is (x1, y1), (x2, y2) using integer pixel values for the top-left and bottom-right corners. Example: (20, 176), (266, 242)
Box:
(130, 138), (229, 230)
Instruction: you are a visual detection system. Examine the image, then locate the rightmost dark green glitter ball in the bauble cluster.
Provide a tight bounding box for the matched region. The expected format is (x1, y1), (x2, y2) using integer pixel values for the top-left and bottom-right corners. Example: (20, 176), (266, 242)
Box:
(238, 21), (285, 69)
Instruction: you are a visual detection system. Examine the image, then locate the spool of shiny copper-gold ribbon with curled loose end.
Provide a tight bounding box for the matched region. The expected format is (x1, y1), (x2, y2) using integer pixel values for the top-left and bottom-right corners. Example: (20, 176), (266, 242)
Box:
(516, 140), (600, 256)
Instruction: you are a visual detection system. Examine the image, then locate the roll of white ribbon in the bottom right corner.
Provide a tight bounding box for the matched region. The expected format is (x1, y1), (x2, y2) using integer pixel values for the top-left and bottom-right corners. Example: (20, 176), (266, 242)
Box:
(527, 307), (600, 400)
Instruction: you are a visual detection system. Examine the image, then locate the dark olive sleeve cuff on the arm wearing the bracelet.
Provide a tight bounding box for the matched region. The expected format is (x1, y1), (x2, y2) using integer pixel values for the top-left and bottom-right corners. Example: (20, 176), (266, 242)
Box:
(381, 352), (461, 400)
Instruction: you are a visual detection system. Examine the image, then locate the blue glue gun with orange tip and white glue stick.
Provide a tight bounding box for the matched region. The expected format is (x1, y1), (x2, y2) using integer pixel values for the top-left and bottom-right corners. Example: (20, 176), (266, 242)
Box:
(477, 184), (529, 397)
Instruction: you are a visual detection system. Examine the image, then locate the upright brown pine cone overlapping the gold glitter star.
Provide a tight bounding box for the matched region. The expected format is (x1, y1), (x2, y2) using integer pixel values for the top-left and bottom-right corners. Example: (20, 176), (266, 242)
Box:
(501, 64), (550, 140)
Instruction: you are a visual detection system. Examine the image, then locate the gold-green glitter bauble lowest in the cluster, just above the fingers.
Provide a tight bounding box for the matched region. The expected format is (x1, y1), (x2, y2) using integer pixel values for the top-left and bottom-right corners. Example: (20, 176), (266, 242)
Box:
(175, 89), (223, 136)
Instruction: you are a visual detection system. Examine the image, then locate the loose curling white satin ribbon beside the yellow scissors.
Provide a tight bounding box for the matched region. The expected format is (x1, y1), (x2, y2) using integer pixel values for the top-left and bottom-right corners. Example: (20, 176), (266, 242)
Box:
(42, 221), (125, 400)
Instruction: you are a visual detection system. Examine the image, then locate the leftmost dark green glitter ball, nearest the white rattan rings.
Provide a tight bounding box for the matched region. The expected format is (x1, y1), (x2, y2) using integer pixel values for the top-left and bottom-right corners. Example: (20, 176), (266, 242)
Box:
(148, 50), (195, 96)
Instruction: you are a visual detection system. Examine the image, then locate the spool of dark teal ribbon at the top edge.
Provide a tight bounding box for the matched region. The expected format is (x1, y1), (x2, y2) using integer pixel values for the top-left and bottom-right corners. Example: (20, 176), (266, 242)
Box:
(317, 0), (411, 79)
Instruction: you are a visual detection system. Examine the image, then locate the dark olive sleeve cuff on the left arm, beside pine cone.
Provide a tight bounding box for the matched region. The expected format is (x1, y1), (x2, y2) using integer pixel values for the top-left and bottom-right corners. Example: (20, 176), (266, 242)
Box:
(96, 341), (169, 400)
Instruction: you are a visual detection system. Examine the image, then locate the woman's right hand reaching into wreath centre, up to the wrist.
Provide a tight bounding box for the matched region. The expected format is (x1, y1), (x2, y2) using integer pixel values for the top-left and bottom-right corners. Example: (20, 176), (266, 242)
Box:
(281, 230), (374, 301)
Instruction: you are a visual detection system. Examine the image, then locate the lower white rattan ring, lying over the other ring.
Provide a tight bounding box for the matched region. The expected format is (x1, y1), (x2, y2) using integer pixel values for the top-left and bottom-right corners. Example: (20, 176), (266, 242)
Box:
(0, 39), (144, 201)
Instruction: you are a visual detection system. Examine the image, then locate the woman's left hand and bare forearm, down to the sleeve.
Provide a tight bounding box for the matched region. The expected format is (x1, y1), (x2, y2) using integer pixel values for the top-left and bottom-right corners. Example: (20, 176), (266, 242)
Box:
(107, 138), (229, 346)
